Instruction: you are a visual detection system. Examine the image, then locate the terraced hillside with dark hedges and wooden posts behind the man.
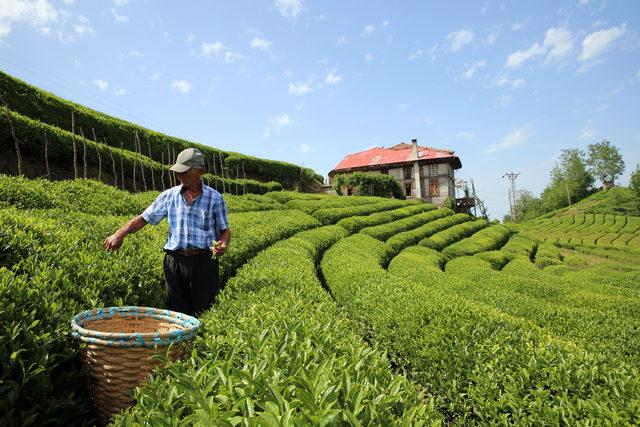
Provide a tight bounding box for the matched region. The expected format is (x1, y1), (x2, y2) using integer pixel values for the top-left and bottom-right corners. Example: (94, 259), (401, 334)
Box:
(0, 71), (323, 192)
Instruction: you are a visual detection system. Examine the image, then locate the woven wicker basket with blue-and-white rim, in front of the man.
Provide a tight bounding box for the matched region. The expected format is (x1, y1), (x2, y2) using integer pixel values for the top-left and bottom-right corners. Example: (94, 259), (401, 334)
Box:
(71, 307), (200, 424)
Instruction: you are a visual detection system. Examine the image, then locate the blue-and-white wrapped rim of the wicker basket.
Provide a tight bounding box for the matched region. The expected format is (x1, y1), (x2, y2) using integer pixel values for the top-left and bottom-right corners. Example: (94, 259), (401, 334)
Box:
(71, 306), (201, 347)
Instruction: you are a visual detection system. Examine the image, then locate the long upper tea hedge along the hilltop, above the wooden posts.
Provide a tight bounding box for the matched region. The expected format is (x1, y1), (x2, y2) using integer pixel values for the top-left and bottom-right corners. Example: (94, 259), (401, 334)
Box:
(0, 71), (323, 190)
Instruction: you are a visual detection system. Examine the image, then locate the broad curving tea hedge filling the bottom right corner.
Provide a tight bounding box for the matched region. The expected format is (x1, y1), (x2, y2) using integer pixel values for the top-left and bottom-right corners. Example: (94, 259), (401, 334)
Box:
(322, 234), (640, 425)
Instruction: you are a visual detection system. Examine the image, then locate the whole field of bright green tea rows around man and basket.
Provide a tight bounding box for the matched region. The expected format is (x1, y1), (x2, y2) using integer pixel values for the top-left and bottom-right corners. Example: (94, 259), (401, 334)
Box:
(0, 176), (640, 426)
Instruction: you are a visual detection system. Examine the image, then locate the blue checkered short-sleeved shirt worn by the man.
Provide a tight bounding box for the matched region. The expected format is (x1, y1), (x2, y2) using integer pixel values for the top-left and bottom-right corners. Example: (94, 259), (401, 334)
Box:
(142, 184), (229, 251)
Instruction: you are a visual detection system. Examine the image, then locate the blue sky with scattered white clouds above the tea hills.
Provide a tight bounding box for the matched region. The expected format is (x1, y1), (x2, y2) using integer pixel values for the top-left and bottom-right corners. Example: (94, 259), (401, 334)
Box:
(0, 0), (640, 218)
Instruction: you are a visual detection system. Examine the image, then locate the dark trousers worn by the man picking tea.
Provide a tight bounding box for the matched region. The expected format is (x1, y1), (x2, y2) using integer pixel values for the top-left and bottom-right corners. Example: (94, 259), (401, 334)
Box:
(164, 253), (220, 316)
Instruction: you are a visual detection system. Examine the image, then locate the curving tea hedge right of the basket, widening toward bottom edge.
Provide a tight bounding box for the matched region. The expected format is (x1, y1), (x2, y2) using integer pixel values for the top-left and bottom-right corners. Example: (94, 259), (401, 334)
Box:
(116, 226), (441, 426)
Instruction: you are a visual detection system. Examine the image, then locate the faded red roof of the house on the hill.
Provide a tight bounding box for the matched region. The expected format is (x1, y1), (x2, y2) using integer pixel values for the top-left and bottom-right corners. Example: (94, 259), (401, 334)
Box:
(332, 142), (462, 172)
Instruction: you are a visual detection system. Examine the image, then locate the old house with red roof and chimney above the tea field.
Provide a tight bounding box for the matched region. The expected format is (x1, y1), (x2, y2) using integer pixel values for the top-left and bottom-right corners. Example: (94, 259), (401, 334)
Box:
(329, 139), (462, 206)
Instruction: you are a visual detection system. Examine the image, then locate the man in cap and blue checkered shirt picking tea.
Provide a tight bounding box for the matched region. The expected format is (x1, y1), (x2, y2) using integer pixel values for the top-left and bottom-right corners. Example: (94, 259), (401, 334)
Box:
(104, 148), (231, 315)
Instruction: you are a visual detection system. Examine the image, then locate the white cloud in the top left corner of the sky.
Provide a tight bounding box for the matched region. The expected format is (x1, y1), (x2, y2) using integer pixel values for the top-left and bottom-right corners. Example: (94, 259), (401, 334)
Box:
(0, 0), (59, 38)
